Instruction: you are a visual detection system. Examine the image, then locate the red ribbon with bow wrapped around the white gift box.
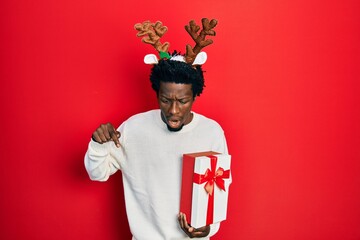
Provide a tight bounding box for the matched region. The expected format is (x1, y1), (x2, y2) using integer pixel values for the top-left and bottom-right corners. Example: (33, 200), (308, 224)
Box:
(193, 156), (230, 225)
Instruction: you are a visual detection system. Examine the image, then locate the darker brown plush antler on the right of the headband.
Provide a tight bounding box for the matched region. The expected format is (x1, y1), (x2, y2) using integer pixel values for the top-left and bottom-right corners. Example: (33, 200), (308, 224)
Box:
(185, 18), (217, 63)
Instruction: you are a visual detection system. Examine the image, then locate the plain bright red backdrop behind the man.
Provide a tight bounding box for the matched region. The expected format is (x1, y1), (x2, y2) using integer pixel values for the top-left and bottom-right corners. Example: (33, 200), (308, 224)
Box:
(0, 0), (360, 240)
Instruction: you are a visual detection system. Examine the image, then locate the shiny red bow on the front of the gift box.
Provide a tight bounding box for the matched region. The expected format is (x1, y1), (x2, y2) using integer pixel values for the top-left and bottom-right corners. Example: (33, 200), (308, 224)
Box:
(194, 159), (230, 195)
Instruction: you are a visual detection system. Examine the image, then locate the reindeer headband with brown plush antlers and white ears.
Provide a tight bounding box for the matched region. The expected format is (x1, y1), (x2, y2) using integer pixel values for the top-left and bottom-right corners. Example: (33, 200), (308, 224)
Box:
(134, 18), (217, 65)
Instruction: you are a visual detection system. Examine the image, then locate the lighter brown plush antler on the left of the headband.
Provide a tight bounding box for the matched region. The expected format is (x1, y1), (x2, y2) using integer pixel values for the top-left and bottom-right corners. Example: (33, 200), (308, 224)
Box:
(134, 21), (170, 52)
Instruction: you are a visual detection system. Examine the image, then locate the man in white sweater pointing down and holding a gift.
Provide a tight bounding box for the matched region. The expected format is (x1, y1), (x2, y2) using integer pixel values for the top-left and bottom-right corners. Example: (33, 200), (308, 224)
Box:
(85, 18), (227, 240)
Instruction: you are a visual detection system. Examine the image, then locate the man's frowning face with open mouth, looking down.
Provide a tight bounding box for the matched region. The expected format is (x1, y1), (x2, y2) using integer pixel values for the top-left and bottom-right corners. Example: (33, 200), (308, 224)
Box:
(158, 82), (194, 131)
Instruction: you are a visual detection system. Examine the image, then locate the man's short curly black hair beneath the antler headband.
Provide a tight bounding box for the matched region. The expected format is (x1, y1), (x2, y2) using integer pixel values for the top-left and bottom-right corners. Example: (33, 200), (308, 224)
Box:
(150, 59), (205, 97)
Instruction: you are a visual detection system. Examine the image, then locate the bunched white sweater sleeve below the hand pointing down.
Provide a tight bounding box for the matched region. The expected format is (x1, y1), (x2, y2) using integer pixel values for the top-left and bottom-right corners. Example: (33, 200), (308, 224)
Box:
(84, 140), (122, 181)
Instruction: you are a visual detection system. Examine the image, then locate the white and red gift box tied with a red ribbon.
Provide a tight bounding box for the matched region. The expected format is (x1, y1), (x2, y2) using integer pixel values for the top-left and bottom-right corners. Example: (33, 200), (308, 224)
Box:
(180, 152), (231, 228)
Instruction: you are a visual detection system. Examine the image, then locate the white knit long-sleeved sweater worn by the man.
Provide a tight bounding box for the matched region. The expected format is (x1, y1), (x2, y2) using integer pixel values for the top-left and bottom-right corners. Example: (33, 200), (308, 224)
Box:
(85, 110), (227, 240)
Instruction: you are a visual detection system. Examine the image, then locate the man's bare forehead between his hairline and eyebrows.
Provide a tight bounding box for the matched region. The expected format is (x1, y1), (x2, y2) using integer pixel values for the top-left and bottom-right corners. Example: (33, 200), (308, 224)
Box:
(159, 82), (193, 97)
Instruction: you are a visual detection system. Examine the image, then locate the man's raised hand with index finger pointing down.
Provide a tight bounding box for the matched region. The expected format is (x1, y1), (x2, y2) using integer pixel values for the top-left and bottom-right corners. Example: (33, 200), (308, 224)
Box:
(92, 123), (120, 147)
